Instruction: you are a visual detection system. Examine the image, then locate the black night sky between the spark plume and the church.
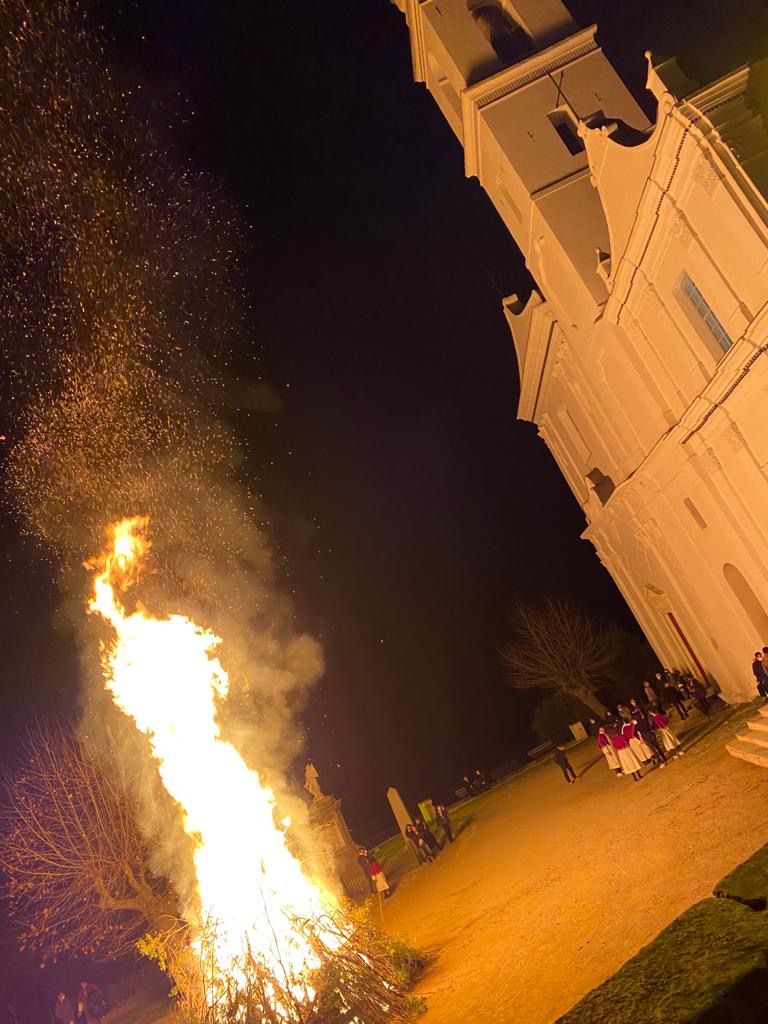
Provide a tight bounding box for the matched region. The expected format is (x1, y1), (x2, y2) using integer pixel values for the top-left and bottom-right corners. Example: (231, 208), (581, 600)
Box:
(0, 0), (768, 838)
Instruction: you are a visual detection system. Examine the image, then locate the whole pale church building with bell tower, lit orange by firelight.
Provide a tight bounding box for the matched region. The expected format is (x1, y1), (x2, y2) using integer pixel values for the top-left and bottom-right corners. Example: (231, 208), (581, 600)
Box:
(397, 0), (768, 701)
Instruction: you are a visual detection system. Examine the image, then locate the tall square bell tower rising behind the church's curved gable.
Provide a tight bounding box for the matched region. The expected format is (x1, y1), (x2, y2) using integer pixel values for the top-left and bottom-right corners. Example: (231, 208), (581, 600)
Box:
(398, 0), (648, 337)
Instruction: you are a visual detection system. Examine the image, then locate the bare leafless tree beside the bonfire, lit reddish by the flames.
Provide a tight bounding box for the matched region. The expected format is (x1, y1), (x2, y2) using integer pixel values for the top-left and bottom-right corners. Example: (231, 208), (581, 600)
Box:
(0, 726), (176, 959)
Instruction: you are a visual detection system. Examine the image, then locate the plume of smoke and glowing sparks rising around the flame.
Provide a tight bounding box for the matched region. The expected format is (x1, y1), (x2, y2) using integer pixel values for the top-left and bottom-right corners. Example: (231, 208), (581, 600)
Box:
(0, 0), (322, 942)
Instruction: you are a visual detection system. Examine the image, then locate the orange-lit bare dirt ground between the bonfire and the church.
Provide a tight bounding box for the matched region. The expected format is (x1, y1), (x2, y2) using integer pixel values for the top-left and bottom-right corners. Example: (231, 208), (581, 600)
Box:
(384, 710), (768, 1024)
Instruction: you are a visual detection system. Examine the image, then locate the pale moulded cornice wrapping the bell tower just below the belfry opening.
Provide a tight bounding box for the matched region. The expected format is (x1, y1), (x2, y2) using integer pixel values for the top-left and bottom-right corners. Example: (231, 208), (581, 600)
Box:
(460, 24), (598, 178)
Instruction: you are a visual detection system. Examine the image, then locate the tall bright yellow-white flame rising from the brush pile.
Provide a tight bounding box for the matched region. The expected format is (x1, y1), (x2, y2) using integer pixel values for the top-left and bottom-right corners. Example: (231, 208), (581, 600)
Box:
(88, 517), (329, 991)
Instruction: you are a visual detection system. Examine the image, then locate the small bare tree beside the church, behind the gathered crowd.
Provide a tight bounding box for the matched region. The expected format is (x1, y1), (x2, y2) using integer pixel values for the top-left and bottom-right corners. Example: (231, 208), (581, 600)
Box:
(502, 600), (614, 715)
